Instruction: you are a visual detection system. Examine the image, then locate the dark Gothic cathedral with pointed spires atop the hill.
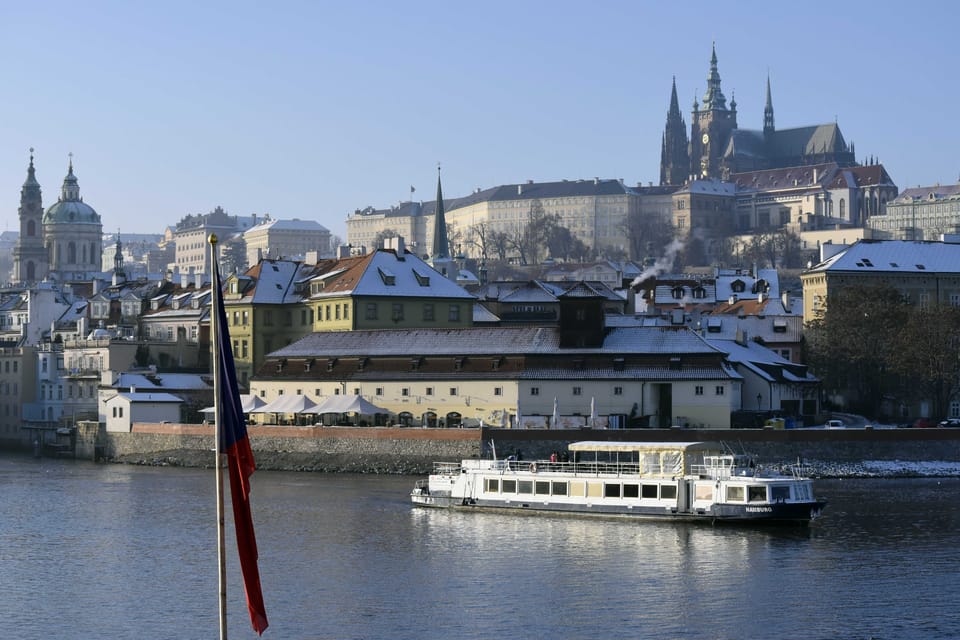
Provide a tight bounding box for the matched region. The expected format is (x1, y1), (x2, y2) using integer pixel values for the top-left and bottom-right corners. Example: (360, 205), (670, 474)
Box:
(660, 46), (856, 186)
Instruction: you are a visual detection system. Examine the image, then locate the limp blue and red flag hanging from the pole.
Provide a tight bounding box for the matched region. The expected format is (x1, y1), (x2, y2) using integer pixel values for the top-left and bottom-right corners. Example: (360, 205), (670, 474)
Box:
(213, 261), (268, 635)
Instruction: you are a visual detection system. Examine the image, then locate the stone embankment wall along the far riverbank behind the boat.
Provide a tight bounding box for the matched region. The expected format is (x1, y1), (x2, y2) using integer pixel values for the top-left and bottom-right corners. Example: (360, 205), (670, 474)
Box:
(77, 422), (960, 474)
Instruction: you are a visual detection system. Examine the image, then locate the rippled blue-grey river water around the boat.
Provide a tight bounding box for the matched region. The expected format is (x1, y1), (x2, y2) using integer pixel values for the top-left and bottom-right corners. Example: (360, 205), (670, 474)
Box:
(0, 455), (960, 640)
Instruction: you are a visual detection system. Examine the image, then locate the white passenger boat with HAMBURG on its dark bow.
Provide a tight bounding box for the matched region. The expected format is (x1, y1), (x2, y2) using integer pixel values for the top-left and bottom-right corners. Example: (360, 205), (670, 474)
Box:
(410, 441), (826, 524)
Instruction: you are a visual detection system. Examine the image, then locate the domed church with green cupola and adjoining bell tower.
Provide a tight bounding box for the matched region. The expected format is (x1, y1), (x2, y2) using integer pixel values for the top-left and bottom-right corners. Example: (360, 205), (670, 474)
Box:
(13, 149), (103, 284)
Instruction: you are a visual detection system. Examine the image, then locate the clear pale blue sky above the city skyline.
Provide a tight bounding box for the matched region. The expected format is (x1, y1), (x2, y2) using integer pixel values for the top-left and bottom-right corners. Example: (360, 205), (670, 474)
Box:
(0, 0), (960, 241)
